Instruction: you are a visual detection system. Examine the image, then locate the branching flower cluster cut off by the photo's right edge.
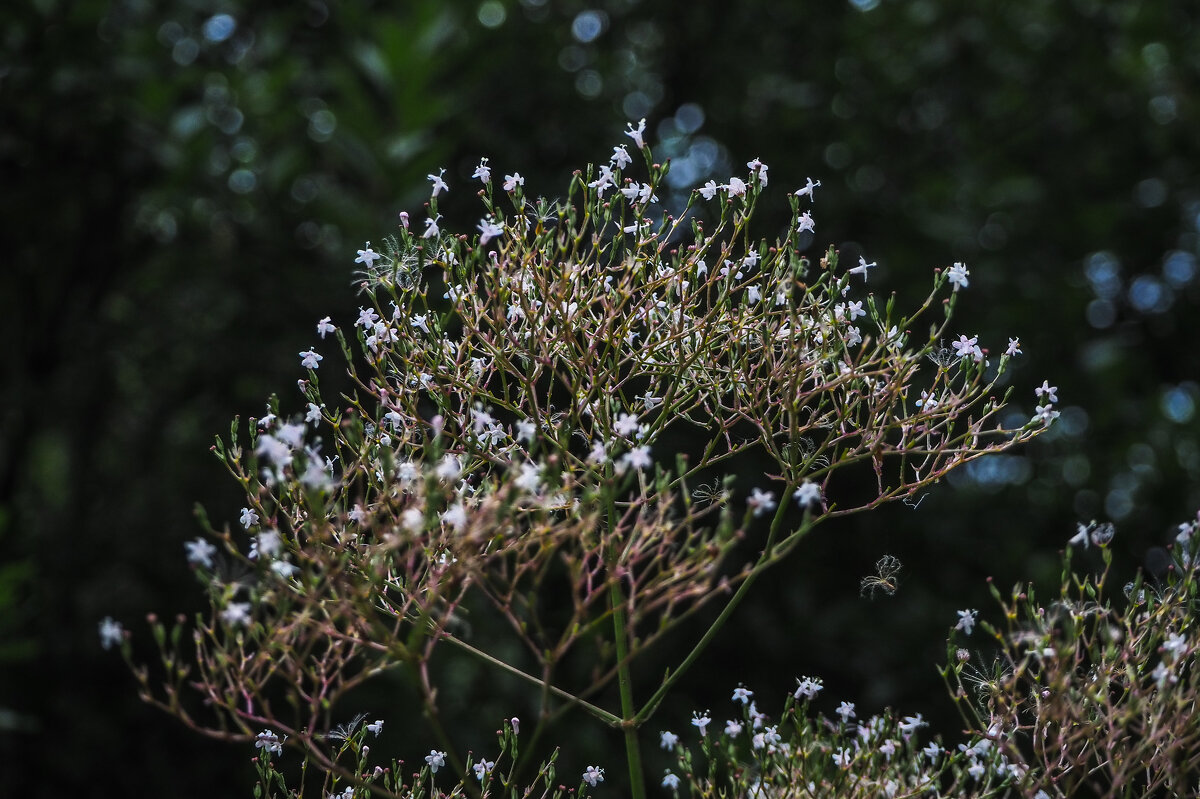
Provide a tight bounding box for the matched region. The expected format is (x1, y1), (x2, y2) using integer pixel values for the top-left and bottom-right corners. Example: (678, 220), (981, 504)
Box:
(943, 517), (1200, 799)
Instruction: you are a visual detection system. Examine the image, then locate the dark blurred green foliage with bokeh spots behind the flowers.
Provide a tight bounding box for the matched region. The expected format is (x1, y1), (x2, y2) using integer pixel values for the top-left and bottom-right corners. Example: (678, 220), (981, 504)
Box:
(0, 0), (1200, 797)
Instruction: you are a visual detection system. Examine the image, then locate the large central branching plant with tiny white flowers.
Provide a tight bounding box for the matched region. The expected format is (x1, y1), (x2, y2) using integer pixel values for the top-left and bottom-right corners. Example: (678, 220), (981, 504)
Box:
(109, 122), (1057, 797)
